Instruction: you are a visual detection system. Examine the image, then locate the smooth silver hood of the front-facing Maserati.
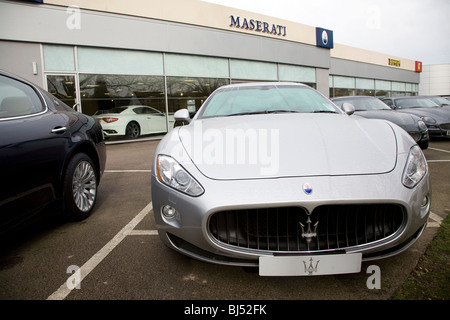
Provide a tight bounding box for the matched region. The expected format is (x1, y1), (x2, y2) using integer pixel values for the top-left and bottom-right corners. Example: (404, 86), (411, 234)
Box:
(179, 114), (397, 180)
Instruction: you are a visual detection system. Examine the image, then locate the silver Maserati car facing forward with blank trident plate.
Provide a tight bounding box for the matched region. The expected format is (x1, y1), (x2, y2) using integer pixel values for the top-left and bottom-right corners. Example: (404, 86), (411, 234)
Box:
(151, 82), (431, 276)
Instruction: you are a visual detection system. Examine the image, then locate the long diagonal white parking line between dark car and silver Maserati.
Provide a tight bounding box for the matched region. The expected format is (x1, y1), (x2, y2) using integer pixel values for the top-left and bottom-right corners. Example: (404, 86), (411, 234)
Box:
(47, 201), (153, 300)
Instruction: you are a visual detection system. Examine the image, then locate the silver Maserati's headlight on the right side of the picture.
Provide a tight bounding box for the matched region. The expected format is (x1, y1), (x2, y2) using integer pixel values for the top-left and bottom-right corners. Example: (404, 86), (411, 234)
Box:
(403, 145), (427, 188)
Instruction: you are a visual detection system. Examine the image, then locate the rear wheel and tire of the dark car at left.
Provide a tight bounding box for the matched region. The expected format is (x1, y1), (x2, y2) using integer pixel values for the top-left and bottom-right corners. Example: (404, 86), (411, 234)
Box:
(63, 153), (98, 221)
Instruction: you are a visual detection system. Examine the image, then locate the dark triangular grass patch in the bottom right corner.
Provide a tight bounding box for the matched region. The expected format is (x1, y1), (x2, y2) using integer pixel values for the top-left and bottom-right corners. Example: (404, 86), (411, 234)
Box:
(393, 214), (450, 300)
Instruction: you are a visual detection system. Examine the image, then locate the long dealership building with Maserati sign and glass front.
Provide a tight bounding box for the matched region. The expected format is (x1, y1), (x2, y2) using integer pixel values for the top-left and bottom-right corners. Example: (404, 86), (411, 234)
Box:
(0, 0), (422, 124)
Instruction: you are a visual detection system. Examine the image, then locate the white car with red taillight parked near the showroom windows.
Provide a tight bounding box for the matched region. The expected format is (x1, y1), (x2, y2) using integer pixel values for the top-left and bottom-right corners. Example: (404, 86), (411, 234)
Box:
(94, 105), (175, 139)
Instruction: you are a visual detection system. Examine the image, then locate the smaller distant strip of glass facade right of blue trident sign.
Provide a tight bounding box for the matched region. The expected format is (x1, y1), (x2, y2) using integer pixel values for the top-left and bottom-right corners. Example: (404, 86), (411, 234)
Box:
(329, 75), (419, 98)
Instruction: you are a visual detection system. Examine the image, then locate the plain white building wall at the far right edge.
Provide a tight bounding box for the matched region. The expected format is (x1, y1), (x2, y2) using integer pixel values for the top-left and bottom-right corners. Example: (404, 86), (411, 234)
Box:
(419, 64), (450, 96)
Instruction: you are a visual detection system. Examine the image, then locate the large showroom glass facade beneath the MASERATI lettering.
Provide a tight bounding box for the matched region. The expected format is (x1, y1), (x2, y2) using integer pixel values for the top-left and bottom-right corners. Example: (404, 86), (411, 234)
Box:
(43, 45), (316, 134)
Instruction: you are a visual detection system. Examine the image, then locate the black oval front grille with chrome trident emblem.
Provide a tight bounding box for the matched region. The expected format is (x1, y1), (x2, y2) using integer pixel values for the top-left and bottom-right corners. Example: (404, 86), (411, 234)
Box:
(209, 204), (405, 252)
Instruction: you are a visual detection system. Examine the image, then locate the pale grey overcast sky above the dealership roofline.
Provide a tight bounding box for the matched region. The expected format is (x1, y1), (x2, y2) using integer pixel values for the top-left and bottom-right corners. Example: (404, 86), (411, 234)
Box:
(204, 0), (450, 65)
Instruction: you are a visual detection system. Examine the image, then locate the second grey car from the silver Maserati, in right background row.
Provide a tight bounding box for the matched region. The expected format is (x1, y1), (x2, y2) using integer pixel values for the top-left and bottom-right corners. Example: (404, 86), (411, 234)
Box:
(382, 96), (450, 138)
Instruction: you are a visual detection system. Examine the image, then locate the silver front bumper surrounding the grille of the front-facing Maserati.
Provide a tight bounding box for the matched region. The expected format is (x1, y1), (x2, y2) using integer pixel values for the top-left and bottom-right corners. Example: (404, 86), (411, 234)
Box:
(152, 161), (431, 266)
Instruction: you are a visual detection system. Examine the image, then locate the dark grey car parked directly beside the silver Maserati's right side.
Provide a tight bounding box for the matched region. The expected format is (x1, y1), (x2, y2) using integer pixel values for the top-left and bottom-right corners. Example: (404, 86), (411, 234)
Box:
(331, 96), (430, 150)
